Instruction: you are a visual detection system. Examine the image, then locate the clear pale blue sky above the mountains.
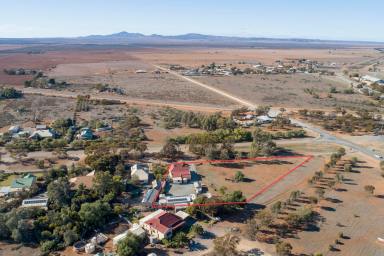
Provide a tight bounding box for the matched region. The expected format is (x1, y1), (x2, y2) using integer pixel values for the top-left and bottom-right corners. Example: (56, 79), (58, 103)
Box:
(0, 0), (384, 41)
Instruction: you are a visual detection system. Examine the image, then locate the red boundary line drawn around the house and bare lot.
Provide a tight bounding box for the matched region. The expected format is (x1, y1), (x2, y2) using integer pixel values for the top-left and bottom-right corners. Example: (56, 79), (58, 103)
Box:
(152, 155), (313, 209)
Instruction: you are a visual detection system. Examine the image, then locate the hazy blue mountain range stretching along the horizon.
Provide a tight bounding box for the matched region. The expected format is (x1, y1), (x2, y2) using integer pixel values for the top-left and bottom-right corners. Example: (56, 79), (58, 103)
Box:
(0, 31), (384, 52)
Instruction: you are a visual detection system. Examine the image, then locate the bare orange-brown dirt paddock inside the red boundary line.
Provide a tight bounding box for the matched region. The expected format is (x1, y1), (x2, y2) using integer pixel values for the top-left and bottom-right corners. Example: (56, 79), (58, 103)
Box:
(196, 157), (305, 198)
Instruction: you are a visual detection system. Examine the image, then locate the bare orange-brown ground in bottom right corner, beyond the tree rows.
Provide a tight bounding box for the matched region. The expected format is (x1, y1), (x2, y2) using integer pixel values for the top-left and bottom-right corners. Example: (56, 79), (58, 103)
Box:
(287, 154), (384, 256)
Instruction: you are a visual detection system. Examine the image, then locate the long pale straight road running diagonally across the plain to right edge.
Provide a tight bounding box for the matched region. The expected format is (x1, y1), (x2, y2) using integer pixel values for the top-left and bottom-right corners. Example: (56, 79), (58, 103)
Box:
(155, 65), (377, 160)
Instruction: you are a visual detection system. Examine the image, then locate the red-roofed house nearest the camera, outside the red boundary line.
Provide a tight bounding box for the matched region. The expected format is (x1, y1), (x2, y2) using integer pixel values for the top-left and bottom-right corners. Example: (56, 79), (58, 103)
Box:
(139, 209), (185, 240)
